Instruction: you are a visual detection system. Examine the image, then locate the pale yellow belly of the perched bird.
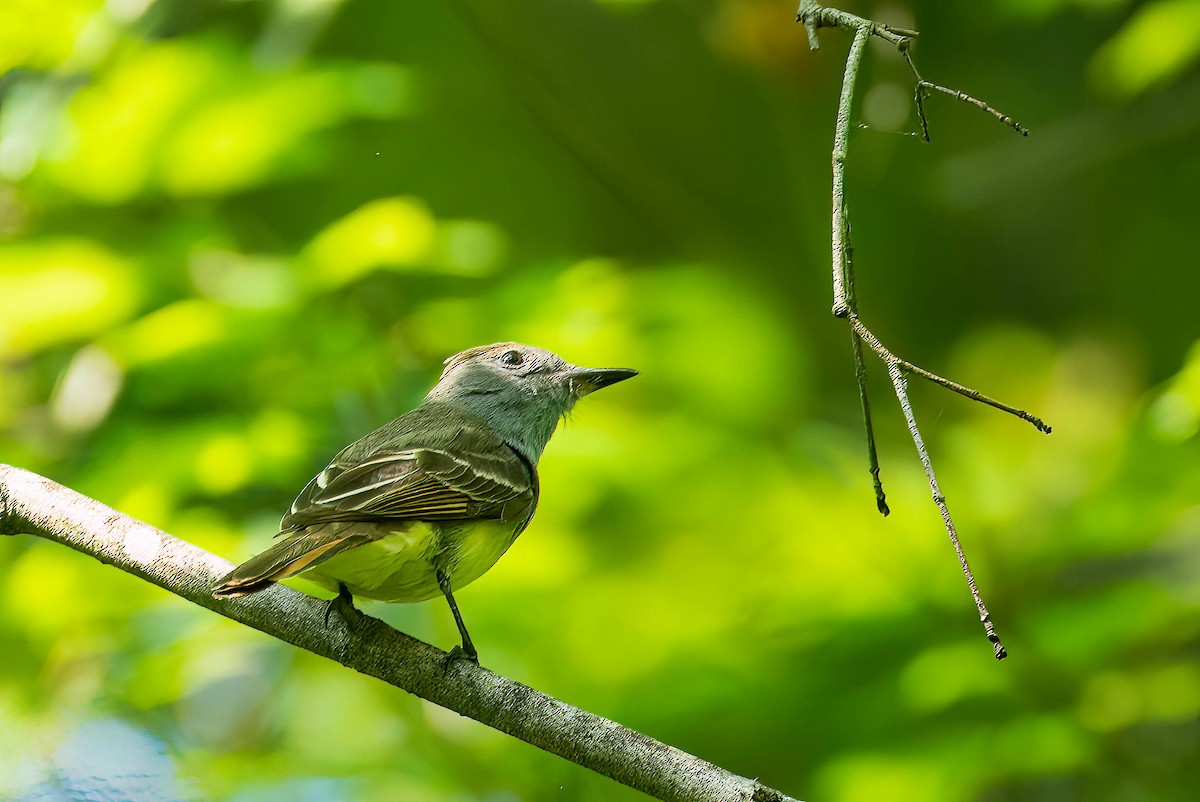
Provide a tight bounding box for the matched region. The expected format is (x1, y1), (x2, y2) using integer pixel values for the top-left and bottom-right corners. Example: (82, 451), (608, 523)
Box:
(302, 521), (516, 602)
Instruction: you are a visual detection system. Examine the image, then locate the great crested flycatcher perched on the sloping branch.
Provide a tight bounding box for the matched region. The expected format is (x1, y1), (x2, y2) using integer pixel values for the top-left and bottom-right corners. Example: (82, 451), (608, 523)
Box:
(212, 342), (637, 663)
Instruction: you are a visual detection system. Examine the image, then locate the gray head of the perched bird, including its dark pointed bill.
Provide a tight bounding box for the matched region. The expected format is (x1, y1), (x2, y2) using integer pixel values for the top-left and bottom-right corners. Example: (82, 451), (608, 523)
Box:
(425, 342), (637, 463)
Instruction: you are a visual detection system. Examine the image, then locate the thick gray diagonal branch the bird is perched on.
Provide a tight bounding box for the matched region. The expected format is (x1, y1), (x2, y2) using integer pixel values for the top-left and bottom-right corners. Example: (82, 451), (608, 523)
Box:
(0, 465), (796, 802)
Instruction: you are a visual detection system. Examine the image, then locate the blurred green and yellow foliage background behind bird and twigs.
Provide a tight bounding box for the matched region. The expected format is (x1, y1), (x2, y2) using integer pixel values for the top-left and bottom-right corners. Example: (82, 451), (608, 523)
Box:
(0, 0), (1200, 802)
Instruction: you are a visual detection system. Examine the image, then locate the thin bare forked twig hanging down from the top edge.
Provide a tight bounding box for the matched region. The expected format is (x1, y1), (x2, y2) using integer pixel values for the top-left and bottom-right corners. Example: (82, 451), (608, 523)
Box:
(796, 0), (1050, 660)
